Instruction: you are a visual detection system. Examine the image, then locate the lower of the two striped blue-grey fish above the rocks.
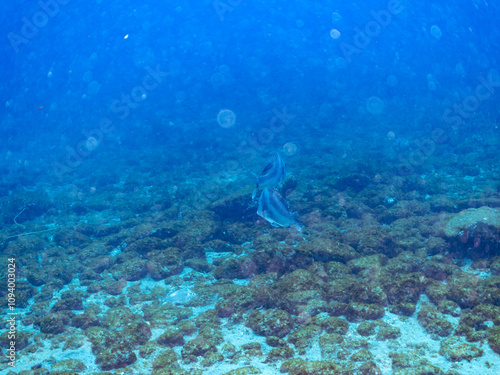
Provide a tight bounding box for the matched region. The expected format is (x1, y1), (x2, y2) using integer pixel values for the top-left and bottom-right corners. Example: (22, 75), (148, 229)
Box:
(257, 187), (305, 232)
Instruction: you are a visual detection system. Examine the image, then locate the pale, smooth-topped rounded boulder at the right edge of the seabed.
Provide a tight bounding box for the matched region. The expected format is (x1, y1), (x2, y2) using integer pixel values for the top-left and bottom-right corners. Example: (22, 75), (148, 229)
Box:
(444, 206), (500, 237)
